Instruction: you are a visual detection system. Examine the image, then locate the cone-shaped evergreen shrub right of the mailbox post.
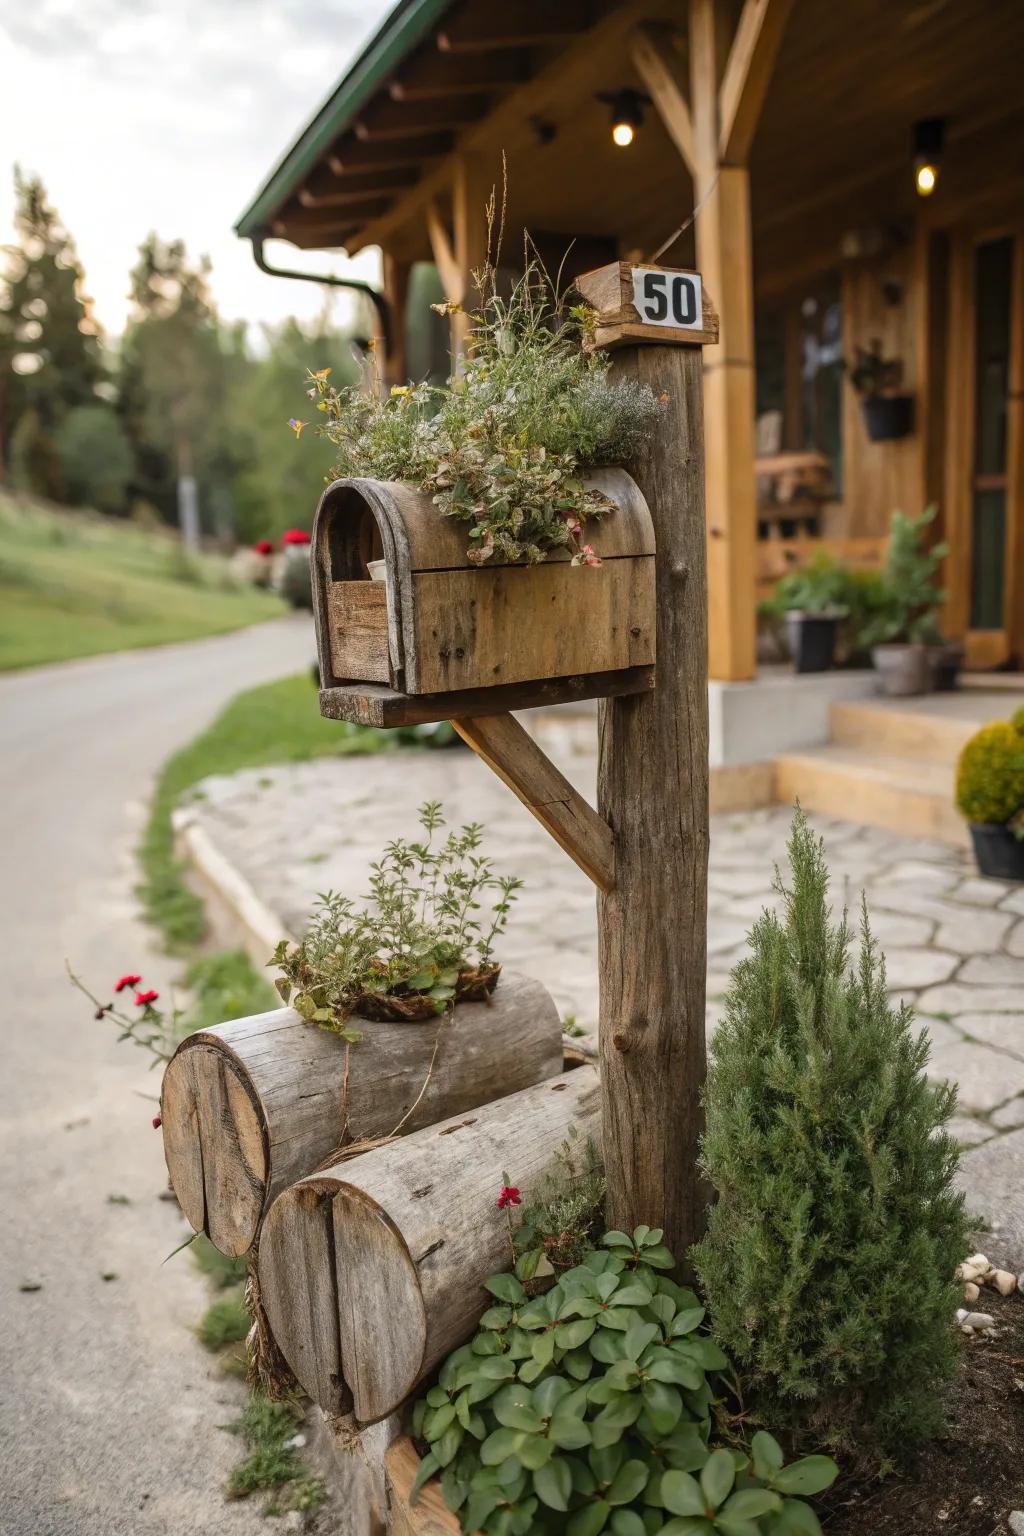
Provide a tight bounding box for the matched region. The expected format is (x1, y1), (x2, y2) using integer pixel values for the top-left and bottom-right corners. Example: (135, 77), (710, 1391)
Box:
(691, 809), (967, 1462)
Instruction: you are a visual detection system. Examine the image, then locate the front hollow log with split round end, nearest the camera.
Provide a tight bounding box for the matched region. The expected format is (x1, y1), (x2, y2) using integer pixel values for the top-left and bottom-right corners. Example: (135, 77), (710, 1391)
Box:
(259, 1066), (600, 1424)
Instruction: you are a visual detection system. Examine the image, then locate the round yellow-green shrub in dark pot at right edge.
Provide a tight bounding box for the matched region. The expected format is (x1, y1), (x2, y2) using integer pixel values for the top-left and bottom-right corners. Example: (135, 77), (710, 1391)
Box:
(956, 705), (1024, 880)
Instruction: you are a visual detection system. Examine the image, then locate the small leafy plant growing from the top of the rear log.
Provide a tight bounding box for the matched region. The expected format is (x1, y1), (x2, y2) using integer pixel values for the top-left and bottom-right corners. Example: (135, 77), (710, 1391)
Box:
(270, 800), (522, 1040)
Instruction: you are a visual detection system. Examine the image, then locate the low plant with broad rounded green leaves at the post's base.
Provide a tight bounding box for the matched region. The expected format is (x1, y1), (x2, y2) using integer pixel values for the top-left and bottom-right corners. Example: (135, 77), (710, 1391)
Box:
(413, 1227), (837, 1536)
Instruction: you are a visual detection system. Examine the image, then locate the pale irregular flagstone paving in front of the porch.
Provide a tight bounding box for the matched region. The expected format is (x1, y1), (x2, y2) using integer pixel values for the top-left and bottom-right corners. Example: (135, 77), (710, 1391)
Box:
(180, 736), (1024, 1269)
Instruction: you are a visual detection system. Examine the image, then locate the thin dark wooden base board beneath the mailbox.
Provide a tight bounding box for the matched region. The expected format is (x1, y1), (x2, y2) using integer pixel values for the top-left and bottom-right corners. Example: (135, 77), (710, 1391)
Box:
(319, 667), (654, 728)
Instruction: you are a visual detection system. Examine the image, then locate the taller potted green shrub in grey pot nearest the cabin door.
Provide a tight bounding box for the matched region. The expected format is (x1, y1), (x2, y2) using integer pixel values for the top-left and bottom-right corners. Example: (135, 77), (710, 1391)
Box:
(861, 507), (946, 697)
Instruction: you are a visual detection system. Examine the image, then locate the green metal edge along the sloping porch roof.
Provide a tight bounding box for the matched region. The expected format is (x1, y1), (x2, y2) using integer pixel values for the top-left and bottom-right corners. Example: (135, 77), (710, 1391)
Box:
(235, 0), (451, 235)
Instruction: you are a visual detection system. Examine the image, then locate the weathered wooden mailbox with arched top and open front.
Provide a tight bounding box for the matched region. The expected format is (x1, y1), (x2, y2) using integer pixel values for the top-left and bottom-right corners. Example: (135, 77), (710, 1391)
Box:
(313, 468), (654, 725)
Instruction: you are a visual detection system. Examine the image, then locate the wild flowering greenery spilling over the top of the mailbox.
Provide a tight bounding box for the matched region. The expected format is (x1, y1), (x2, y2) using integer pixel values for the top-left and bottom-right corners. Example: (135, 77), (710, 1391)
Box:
(300, 239), (662, 565)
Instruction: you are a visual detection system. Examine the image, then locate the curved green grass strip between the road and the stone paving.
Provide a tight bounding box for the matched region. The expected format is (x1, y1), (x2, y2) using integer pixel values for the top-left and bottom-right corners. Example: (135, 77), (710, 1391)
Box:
(140, 673), (448, 946)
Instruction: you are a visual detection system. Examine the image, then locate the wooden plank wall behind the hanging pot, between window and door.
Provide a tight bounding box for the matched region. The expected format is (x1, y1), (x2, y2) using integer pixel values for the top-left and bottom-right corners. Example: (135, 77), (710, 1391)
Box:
(841, 246), (927, 539)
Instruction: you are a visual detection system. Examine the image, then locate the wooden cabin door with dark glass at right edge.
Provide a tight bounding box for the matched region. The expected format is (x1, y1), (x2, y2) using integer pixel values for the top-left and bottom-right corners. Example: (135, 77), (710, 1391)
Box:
(947, 227), (1024, 668)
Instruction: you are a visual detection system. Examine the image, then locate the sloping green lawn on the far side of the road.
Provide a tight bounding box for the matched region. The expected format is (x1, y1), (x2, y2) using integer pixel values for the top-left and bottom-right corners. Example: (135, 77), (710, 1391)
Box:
(0, 493), (286, 671)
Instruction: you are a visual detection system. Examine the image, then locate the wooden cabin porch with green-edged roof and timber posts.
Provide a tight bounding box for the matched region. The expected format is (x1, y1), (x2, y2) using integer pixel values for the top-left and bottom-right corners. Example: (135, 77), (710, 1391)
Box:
(238, 0), (1024, 680)
